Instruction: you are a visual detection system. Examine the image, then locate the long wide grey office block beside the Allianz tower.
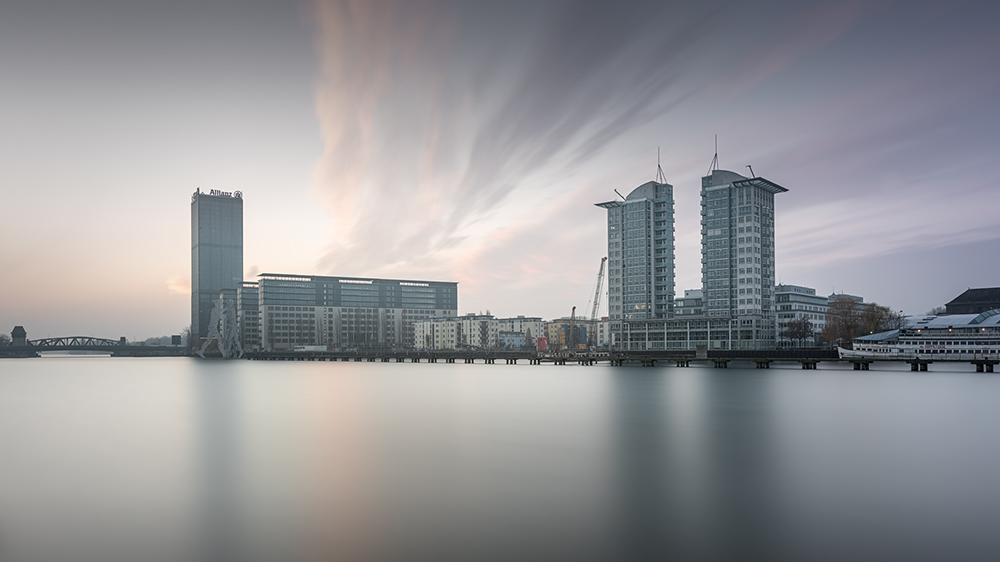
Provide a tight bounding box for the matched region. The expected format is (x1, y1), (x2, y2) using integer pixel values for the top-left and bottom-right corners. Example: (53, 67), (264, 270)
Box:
(257, 273), (458, 351)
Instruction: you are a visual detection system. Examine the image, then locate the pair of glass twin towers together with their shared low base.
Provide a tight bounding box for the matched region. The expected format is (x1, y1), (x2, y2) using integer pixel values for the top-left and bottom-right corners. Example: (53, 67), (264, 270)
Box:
(597, 170), (788, 350)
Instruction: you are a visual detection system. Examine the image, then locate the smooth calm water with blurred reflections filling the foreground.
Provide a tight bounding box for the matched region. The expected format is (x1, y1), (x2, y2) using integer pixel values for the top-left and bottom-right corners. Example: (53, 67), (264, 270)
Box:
(0, 357), (1000, 561)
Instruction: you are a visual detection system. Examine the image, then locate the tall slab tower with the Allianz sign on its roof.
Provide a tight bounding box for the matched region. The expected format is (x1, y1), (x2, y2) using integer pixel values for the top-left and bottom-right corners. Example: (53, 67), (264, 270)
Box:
(191, 189), (243, 349)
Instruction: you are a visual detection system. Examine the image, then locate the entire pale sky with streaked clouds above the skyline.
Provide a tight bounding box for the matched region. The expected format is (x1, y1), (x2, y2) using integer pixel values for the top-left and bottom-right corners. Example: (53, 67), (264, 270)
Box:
(0, 0), (1000, 339)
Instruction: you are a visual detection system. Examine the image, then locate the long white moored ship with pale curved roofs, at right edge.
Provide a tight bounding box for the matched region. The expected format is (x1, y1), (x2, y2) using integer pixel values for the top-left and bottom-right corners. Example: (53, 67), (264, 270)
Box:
(840, 309), (1000, 360)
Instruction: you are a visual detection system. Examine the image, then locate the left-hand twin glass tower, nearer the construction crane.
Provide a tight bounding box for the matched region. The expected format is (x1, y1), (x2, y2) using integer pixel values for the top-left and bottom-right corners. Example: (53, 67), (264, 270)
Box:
(592, 176), (674, 345)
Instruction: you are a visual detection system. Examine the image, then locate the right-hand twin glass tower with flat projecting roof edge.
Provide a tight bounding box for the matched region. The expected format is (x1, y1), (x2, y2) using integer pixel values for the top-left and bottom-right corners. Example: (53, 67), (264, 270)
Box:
(701, 170), (788, 349)
